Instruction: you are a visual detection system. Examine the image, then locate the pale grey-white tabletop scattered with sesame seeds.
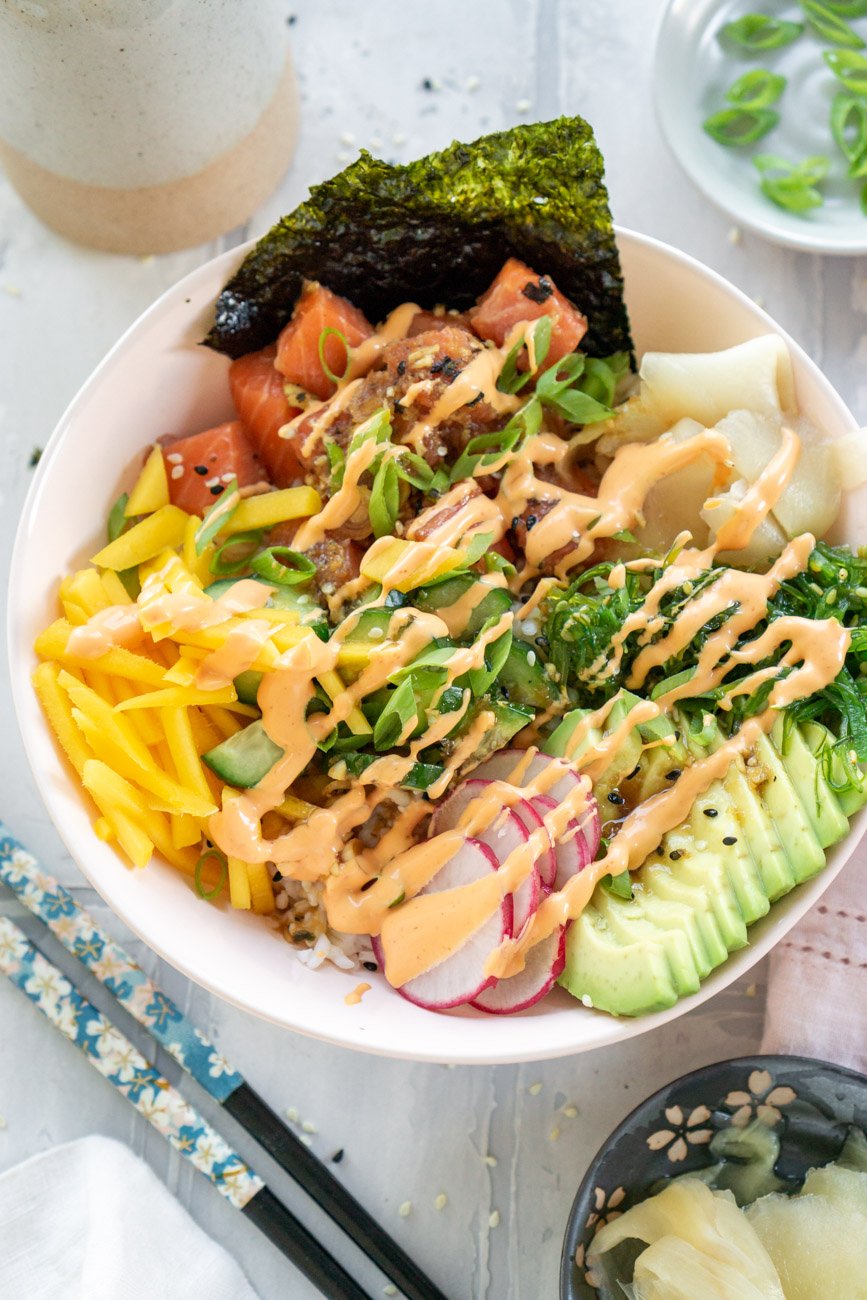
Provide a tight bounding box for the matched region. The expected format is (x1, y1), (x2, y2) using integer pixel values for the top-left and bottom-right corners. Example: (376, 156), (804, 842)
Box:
(0, 0), (852, 1300)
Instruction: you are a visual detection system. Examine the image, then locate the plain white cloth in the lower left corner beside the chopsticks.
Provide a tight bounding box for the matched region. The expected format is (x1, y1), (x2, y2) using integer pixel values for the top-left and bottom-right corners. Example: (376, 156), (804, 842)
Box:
(0, 1136), (256, 1300)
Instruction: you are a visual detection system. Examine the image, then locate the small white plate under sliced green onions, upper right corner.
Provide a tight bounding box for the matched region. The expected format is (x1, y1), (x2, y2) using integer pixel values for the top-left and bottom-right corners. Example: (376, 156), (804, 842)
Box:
(654, 0), (867, 254)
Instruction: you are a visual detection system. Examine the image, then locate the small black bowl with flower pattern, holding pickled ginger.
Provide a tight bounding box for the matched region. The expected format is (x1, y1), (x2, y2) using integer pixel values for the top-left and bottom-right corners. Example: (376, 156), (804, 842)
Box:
(560, 1056), (867, 1300)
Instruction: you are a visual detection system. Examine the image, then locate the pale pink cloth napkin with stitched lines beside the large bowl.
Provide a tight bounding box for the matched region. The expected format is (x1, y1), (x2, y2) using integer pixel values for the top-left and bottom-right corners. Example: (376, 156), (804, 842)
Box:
(762, 842), (867, 1073)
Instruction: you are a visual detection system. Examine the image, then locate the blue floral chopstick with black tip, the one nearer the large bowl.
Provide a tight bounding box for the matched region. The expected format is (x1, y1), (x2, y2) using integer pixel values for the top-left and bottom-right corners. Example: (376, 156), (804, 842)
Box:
(0, 822), (446, 1300)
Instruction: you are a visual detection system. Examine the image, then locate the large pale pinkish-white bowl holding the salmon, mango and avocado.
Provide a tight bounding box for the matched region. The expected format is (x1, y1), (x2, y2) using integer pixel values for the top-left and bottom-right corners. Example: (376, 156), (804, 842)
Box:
(9, 230), (867, 1062)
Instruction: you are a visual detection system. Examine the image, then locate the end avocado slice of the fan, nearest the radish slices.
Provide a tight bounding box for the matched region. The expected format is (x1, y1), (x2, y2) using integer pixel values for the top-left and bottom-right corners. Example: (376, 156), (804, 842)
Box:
(560, 892), (679, 1015)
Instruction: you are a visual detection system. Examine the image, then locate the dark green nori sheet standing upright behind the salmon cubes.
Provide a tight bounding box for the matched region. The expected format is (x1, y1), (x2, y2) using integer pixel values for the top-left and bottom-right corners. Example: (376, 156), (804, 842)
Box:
(205, 117), (632, 356)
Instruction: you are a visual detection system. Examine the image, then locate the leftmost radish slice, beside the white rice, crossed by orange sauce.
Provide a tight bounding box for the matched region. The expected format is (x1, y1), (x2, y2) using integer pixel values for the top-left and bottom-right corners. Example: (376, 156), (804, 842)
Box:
(373, 839), (512, 1011)
